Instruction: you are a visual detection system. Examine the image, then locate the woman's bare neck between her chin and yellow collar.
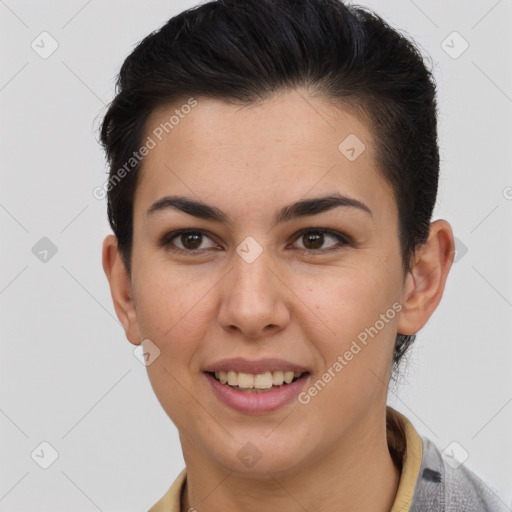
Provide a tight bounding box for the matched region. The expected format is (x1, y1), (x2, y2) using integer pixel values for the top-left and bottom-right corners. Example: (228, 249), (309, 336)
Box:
(181, 410), (400, 512)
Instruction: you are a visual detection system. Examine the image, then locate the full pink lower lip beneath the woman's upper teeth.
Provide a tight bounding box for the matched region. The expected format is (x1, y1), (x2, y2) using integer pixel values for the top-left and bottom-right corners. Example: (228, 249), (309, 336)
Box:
(205, 373), (309, 414)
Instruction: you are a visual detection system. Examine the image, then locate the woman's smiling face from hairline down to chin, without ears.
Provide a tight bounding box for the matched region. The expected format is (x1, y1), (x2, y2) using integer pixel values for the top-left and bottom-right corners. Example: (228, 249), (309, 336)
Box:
(127, 90), (404, 475)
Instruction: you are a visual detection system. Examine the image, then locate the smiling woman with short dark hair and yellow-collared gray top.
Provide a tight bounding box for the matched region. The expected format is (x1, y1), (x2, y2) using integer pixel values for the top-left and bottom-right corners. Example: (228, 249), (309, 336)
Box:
(101, 0), (506, 512)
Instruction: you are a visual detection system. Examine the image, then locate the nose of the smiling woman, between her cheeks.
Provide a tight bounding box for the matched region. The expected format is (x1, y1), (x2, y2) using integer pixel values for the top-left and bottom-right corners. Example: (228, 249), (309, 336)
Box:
(218, 247), (291, 340)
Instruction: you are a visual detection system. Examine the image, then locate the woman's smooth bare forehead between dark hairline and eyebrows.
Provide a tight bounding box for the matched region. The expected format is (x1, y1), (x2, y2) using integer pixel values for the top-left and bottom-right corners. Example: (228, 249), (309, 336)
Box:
(135, 89), (394, 224)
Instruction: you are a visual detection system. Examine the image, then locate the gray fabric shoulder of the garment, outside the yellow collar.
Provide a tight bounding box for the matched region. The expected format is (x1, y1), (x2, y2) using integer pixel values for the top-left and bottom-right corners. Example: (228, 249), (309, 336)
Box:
(410, 437), (512, 512)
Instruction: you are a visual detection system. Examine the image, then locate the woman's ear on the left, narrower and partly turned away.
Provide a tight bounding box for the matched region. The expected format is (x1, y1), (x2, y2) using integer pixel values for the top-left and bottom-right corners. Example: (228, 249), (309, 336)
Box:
(102, 235), (141, 345)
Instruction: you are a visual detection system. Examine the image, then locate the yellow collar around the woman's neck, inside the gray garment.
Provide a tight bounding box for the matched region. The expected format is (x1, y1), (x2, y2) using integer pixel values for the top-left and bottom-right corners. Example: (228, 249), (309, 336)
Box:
(148, 406), (423, 512)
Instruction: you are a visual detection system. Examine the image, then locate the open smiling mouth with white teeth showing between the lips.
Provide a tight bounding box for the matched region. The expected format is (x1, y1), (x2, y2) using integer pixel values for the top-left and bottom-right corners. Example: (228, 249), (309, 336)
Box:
(206, 370), (309, 393)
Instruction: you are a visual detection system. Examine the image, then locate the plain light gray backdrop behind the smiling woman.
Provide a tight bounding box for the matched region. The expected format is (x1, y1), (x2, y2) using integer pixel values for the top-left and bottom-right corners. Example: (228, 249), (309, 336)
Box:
(0, 0), (512, 512)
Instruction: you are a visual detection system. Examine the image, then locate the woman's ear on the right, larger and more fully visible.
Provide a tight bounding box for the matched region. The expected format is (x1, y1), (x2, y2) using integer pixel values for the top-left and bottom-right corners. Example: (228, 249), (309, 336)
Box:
(397, 220), (455, 334)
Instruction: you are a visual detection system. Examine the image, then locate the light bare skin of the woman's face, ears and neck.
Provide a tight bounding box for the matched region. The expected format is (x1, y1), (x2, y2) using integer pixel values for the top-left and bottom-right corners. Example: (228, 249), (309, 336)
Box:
(103, 89), (455, 512)
